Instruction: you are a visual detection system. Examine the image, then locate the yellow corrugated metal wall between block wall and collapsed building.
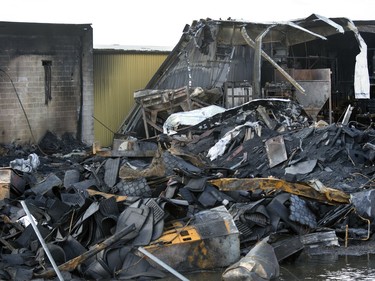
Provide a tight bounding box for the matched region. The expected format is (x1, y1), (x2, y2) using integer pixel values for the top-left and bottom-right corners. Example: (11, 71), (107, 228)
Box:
(93, 50), (168, 147)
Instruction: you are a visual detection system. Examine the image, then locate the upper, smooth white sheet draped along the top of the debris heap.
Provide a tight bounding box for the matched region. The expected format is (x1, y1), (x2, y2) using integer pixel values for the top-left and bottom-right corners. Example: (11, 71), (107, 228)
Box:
(163, 105), (225, 135)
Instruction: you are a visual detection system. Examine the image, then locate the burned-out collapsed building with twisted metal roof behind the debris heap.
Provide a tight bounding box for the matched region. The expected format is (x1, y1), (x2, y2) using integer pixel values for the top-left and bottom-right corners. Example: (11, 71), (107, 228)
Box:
(121, 14), (375, 137)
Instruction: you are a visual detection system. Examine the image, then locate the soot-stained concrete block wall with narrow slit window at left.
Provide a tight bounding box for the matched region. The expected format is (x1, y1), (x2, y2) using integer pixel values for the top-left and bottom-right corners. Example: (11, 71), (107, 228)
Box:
(0, 22), (93, 144)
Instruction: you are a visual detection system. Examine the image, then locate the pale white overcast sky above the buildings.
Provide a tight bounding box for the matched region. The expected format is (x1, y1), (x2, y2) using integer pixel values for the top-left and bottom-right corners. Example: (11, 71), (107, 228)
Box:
(0, 0), (375, 48)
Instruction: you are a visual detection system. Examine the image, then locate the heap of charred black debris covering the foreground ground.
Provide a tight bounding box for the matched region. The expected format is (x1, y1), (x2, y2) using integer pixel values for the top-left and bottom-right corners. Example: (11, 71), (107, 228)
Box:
(0, 99), (375, 280)
